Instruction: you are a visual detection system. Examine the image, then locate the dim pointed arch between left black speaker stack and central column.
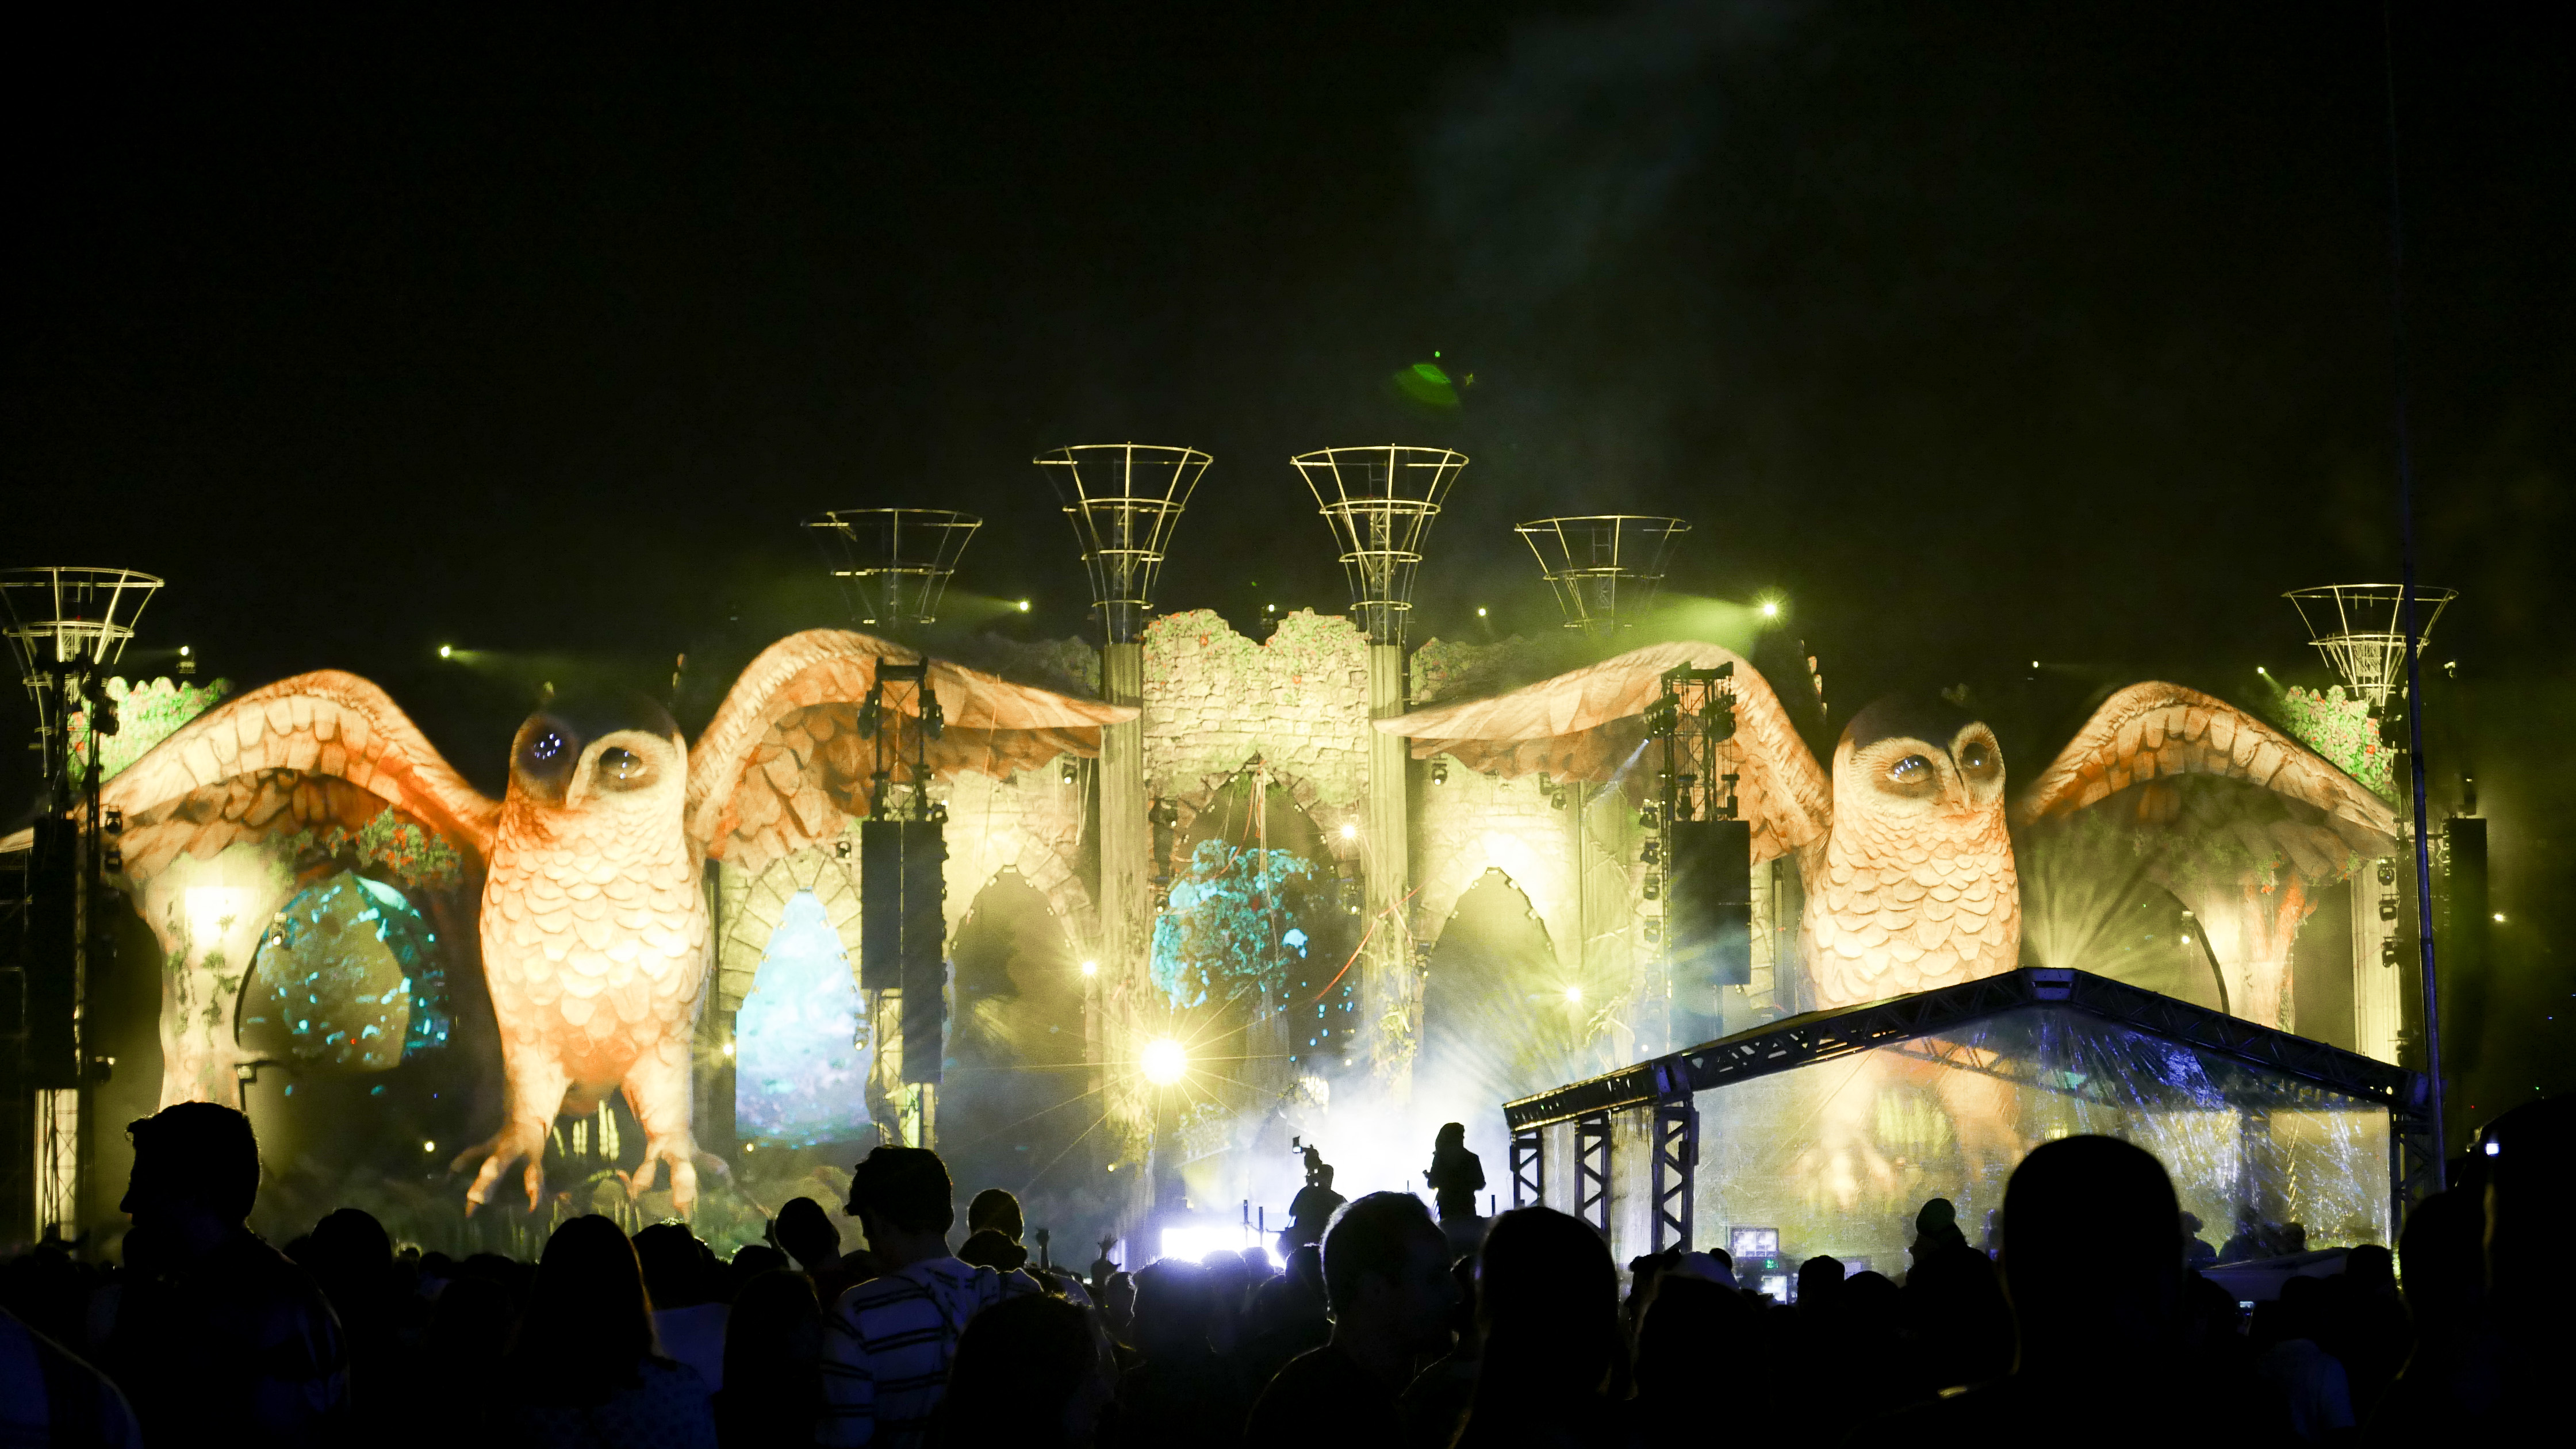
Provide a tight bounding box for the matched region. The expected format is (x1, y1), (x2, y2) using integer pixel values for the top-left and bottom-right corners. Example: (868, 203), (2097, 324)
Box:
(938, 872), (1107, 1227)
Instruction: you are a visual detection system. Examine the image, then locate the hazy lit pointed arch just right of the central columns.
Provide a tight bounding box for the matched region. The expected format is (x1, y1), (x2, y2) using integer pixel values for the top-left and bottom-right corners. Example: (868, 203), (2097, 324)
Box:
(1414, 869), (1594, 1191)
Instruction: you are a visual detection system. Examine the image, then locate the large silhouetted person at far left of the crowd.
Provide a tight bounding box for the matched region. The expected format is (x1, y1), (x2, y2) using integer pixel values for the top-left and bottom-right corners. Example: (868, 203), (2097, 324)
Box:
(101, 1101), (350, 1444)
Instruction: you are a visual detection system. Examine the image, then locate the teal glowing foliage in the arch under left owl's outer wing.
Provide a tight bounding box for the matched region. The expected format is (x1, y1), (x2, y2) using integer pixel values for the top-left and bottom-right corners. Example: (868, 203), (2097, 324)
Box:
(237, 872), (456, 1072)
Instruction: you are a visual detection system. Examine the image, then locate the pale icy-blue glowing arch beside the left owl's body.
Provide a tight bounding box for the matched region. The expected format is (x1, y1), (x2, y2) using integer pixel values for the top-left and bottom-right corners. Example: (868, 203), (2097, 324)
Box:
(734, 890), (871, 1147)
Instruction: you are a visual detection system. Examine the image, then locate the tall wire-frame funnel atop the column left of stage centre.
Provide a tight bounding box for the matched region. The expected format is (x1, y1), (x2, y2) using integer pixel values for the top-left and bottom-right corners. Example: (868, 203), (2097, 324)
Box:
(1033, 443), (1211, 639)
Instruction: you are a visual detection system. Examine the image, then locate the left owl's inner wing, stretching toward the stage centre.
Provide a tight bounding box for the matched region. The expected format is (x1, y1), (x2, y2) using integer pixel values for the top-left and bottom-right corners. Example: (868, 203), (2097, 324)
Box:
(688, 629), (1136, 869)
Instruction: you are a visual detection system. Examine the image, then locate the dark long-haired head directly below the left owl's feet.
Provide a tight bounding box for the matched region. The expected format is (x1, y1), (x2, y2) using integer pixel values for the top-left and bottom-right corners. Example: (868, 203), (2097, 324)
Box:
(510, 1214), (657, 1402)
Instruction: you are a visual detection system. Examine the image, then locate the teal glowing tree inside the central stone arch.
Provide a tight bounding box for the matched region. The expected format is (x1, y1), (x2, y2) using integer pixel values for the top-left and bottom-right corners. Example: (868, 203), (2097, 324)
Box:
(1154, 841), (1316, 1008)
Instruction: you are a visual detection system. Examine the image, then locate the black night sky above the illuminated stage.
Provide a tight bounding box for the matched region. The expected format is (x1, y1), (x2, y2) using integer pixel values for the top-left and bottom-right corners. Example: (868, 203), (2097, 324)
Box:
(0, 2), (2576, 1117)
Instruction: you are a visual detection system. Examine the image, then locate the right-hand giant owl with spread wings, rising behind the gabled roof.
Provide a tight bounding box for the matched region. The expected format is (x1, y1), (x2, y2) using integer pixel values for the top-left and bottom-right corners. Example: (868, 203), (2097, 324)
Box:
(1378, 645), (2395, 1026)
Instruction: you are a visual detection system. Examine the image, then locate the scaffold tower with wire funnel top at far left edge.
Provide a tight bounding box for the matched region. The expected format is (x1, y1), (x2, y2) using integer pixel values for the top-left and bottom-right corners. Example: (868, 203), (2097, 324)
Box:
(0, 565), (162, 1240)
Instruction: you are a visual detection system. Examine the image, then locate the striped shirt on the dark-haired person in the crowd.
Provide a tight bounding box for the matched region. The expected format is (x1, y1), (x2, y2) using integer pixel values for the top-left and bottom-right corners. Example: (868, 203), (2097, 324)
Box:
(814, 1258), (1038, 1449)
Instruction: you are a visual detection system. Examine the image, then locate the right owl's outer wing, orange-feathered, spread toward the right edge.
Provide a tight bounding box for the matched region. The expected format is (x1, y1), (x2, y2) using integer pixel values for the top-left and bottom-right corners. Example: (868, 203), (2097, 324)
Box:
(2012, 681), (2398, 856)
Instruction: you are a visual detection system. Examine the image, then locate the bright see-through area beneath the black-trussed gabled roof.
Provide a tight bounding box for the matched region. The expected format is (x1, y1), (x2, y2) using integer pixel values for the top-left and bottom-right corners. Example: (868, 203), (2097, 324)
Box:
(1669, 1011), (2390, 1271)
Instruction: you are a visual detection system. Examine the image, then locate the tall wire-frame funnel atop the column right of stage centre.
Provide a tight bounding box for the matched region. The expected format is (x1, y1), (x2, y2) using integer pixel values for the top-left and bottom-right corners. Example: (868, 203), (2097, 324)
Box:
(1288, 446), (1466, 647)
